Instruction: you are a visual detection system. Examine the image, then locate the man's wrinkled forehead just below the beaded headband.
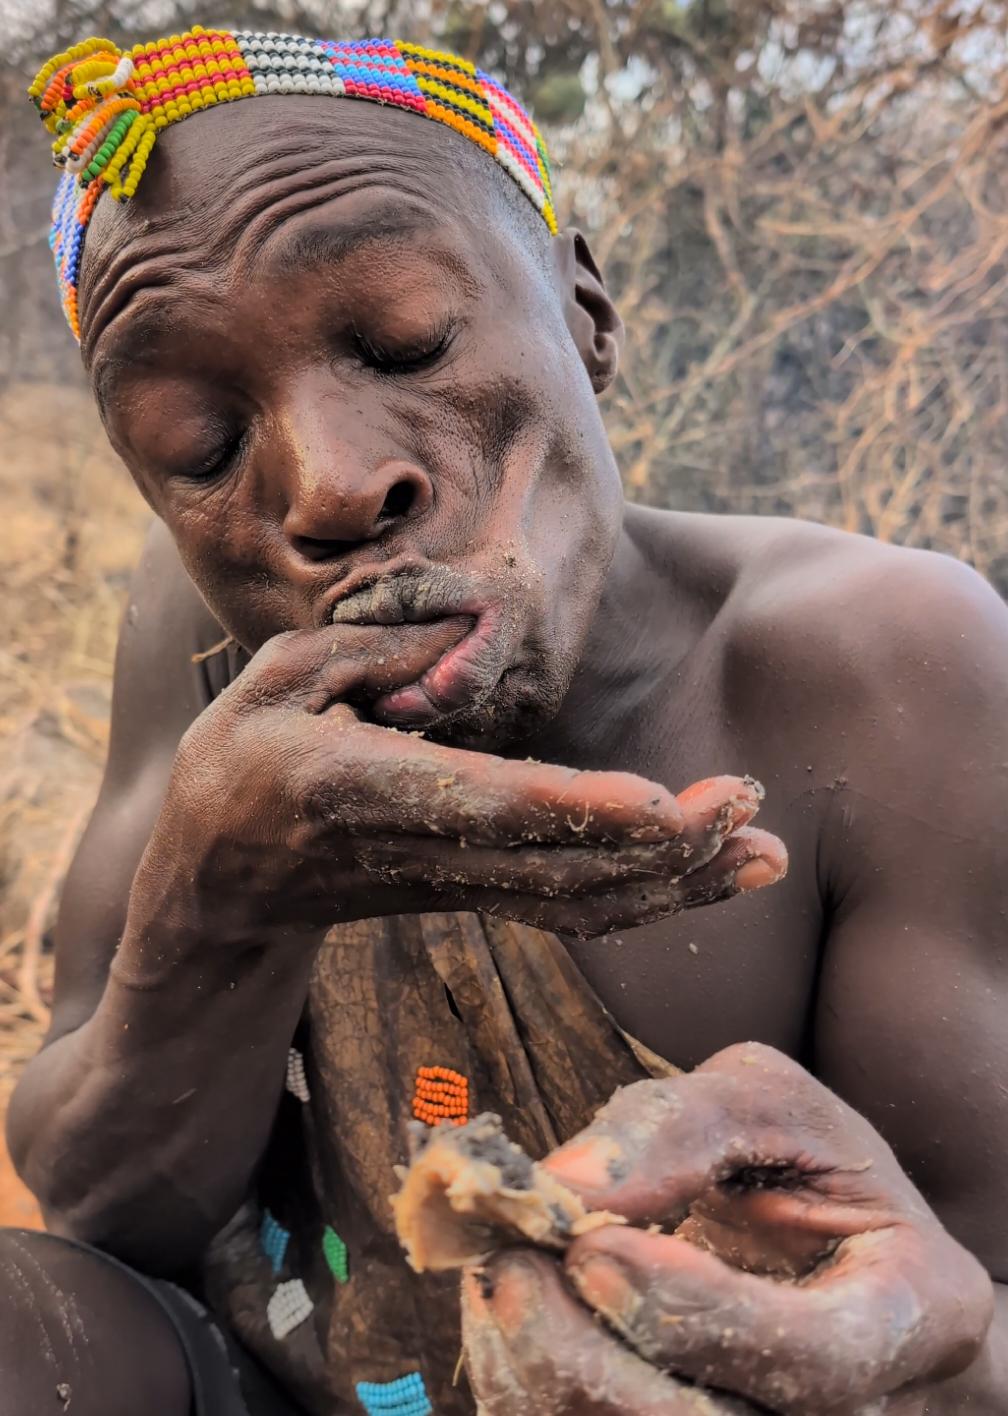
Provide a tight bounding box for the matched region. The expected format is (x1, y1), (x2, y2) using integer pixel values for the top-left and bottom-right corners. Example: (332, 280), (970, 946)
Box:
(81, 95), (535, 362)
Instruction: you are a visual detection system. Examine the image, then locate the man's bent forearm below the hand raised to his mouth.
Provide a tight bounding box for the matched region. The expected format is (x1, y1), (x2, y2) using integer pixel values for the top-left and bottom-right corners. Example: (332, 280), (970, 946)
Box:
(10, 896), (317, 1272)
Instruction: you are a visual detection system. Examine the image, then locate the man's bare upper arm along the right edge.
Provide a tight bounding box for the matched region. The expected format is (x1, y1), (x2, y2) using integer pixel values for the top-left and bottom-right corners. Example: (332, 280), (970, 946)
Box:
(815, 558), (1008, 1280)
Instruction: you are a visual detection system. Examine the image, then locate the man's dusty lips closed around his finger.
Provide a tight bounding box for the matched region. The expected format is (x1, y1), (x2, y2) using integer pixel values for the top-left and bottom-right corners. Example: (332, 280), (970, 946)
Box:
(330, 566), (507, 728)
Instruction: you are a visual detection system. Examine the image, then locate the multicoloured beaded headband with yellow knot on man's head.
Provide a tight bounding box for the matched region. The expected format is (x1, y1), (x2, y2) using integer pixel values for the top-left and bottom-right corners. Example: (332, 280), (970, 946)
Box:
(28, 25), (556, 340)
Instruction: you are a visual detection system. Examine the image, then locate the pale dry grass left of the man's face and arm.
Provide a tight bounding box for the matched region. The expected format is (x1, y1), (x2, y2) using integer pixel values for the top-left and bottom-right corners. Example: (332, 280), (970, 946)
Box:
(0, 385), (149, 1110)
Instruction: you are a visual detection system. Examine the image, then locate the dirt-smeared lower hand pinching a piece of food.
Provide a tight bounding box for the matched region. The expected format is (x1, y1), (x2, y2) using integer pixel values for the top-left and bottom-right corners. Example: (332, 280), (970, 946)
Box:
(464, 1044), (992, 1416)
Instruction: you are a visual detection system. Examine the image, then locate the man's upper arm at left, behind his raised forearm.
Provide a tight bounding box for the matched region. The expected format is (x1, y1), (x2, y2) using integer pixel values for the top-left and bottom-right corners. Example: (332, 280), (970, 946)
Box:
(47, 523), (230, 1041)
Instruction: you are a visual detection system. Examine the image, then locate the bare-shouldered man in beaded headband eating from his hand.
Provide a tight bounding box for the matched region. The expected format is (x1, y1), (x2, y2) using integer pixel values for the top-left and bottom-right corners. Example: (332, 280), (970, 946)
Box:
(7, 31), (1008, 1416)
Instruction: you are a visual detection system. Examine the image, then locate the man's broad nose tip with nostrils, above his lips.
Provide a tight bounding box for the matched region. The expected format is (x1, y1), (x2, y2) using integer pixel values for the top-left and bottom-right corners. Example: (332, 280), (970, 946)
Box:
(283, 449), (433, 561)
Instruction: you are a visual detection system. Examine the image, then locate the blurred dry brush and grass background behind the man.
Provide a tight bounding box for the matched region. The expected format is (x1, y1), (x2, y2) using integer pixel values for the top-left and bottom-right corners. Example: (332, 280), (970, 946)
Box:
(0, 0), (1008, 1138)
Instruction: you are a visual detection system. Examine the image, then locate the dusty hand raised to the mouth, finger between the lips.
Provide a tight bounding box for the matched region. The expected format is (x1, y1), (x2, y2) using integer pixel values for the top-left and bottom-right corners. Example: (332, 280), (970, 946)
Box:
(134, 619), (787, 936)
